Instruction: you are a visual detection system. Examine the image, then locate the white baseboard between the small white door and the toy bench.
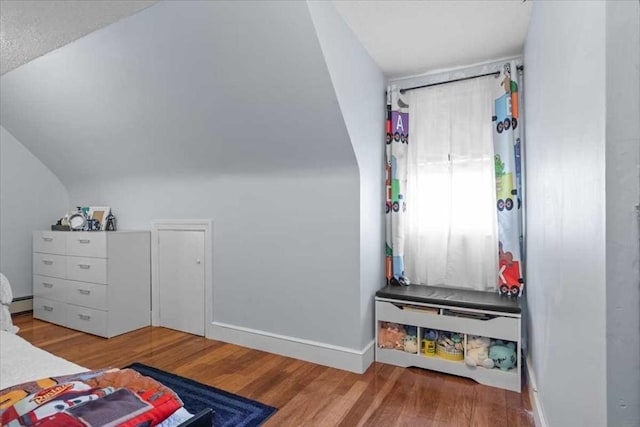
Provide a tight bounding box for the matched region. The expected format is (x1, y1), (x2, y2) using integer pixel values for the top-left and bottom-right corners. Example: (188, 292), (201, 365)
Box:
(207, 322), (375, 374)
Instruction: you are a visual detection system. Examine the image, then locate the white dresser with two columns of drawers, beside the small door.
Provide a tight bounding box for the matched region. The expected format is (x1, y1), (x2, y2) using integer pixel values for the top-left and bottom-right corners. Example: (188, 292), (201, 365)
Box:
(33, 231), (151, 338)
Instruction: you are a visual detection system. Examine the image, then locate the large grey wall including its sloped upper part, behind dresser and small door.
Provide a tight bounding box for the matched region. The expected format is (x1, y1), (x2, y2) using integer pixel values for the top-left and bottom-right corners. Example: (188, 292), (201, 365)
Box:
(0, 1), (372, 358)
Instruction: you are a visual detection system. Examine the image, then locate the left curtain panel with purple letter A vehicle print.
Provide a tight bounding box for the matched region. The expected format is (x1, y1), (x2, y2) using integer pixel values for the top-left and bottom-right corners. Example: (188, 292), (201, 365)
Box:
(385, 86), (409, 285)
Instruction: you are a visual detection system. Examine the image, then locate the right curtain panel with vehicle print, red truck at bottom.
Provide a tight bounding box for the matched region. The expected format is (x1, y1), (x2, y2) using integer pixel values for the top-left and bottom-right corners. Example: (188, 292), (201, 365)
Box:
(493, 62), (524, 296)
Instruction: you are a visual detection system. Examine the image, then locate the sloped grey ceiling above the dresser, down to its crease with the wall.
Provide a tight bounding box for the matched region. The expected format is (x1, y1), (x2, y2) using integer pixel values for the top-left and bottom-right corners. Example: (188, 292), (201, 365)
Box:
(0, 1), (357, 186)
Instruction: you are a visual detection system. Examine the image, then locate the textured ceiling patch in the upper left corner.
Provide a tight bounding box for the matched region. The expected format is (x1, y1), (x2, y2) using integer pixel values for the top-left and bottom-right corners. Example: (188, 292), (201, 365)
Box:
(0, 0), (156, 75)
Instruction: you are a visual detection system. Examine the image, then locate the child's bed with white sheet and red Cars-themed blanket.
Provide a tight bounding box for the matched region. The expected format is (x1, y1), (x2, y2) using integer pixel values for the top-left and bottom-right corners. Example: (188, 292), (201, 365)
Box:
(0, 330), (212, 427)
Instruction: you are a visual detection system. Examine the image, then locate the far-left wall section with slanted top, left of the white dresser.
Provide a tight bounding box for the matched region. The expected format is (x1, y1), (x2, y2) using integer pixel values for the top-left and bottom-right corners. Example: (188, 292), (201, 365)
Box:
(0, 126), (69, 298)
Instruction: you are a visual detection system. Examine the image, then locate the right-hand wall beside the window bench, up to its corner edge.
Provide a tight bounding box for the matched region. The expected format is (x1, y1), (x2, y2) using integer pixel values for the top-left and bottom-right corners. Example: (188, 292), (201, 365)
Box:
(524, 2), (607, 427)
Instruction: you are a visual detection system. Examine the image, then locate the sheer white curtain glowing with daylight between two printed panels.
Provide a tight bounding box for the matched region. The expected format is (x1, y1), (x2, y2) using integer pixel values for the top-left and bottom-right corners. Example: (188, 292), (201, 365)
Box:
(405, 77), (498, 290)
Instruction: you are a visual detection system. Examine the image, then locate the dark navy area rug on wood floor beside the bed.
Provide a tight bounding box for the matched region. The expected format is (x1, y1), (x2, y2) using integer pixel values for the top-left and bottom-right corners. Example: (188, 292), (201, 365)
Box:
(127, 363), (277, 427)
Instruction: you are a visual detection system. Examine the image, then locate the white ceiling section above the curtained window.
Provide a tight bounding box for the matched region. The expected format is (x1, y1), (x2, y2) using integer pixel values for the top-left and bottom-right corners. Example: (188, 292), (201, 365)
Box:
(333, 0), (532, 77)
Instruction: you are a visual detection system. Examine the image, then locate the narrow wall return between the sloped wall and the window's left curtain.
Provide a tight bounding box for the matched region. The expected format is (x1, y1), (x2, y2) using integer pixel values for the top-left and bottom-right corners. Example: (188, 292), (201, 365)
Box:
(308, 1), (386, 347)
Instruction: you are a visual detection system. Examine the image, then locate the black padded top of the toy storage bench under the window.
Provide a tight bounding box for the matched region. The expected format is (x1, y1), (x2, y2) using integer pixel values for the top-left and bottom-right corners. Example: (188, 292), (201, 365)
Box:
(376, 285), (521, 313)
